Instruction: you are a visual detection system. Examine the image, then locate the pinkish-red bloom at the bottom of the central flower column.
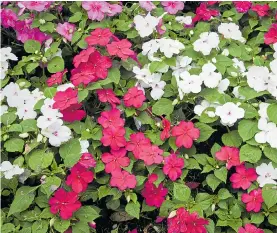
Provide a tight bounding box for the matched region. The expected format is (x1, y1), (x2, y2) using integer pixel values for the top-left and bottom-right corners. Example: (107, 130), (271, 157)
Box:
(110, 171), (137, 191)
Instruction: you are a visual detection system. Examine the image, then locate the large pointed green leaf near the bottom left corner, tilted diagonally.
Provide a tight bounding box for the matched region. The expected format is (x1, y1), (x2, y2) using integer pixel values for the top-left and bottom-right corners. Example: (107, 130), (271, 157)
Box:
(8, 186), (38, 216)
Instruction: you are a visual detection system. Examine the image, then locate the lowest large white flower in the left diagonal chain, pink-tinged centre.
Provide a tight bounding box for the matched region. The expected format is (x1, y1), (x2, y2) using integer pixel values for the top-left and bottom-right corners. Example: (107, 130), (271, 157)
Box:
(41, 119), (71, 147)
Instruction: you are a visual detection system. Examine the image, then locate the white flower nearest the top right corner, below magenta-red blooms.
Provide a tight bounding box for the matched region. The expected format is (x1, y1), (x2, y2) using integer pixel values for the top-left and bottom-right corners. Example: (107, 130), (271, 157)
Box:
(218, 23), (245, 42)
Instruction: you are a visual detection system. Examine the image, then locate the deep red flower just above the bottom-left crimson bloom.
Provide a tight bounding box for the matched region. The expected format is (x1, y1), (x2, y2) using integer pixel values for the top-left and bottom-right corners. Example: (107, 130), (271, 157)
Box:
(65, 163), (94, 193)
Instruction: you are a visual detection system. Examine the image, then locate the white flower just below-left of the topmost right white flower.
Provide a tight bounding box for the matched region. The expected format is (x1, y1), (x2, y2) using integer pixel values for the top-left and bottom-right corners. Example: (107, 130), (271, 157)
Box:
(193, 32), (219, 55)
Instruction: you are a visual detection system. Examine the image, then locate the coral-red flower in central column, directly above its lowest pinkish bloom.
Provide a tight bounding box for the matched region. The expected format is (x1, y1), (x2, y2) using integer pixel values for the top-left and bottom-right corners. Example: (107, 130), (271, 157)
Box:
(101, 148), (130, 173)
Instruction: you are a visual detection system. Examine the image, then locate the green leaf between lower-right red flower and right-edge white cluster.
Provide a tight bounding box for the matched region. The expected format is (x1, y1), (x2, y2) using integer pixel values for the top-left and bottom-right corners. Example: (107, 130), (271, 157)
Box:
(240, 144), (262, 163)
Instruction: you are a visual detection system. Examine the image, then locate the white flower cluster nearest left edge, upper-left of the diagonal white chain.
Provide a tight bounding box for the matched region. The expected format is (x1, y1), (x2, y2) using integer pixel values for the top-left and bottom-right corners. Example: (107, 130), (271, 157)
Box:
(2, 82), (45, 120)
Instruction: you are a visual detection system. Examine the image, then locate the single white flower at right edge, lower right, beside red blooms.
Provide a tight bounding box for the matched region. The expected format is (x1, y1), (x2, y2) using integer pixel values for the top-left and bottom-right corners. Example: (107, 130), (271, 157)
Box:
(256, 162), (277, 187)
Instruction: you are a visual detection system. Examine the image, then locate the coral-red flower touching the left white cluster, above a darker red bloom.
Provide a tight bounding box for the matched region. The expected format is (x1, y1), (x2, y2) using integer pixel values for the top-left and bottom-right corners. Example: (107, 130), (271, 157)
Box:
(53, 88), (78, 111)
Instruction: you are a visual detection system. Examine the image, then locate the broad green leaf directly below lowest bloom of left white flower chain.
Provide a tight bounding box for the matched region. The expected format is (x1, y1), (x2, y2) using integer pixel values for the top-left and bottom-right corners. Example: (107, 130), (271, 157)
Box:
(59, 139), (81, 167)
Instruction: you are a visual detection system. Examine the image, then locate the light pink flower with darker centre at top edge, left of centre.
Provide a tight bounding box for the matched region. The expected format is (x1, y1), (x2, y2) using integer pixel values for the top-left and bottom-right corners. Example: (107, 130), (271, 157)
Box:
(82, 1), (110, 21)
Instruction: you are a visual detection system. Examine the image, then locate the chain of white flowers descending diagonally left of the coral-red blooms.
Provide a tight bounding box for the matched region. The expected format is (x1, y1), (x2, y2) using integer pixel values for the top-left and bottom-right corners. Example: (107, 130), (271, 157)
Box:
(37, 99), (71, 147)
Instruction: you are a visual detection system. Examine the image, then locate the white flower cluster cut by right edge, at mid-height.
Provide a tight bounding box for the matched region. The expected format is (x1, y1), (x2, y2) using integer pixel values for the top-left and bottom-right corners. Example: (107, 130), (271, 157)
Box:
(255, 103), (277, 148)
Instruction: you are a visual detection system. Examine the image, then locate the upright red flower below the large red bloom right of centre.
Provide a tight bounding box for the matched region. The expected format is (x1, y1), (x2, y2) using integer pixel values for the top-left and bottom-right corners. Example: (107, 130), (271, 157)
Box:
(163, 154), (185, 181)
